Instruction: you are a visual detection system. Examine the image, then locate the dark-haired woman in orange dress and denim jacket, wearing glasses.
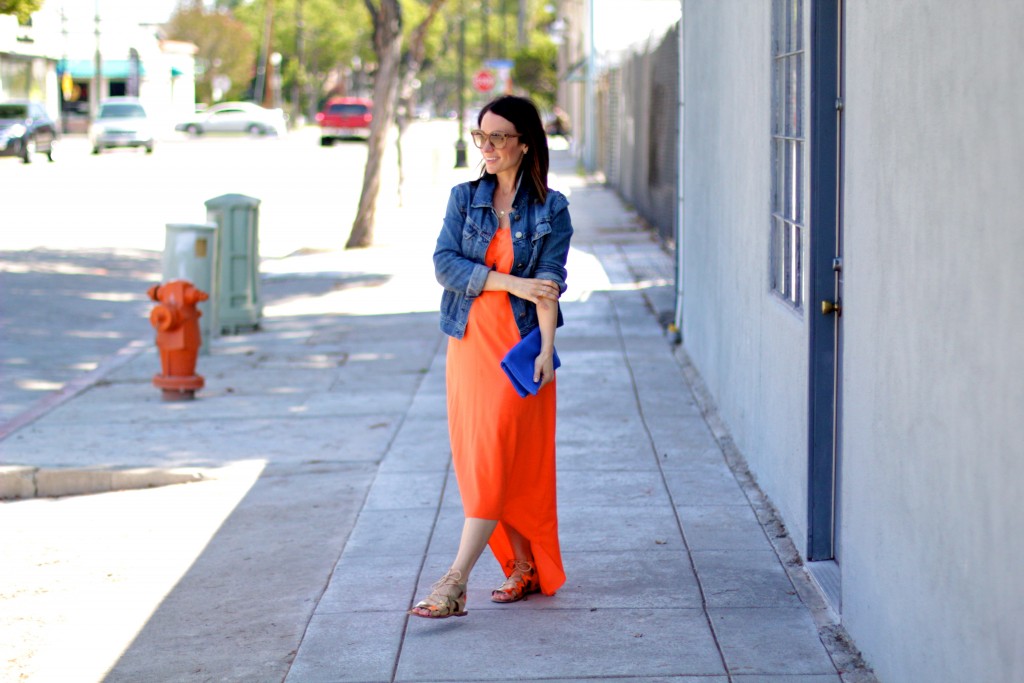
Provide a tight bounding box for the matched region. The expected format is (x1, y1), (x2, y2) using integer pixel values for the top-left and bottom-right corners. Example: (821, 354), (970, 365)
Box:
(410, 95), (572, 618)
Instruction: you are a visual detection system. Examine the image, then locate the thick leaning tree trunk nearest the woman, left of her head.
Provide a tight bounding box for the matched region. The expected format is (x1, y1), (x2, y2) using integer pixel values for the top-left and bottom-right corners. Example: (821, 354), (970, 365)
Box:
(345, 0), (401, 249)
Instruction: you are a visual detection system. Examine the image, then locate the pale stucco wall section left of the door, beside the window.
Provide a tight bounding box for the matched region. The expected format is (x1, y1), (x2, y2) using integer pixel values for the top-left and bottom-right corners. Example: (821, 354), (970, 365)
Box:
(683, 0), (808, 550)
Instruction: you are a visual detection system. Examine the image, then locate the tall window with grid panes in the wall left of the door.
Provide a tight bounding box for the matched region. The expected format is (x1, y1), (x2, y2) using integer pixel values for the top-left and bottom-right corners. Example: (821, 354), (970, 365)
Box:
(770, 0), (807, 308)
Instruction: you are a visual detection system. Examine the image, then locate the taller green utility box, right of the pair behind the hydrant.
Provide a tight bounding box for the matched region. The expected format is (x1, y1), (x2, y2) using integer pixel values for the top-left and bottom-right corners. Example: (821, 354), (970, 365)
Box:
(206, 195), (263, 334)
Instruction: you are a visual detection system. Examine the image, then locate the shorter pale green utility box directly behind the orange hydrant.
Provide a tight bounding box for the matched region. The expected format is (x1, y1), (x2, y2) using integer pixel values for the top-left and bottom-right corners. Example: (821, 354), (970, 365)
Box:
(163, 223), (218, 355)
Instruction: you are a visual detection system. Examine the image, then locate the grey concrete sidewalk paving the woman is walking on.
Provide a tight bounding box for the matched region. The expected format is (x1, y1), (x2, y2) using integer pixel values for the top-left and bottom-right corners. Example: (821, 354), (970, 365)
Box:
(0, 152), (873, 683)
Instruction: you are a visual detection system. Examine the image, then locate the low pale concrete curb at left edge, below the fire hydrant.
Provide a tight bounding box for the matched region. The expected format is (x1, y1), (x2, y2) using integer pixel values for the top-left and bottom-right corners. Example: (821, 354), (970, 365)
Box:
(0, 465), (208, 501)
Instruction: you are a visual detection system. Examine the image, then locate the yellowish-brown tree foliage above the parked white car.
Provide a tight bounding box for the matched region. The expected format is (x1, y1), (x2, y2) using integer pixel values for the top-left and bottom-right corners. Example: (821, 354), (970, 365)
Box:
(167, 0), (256, 102)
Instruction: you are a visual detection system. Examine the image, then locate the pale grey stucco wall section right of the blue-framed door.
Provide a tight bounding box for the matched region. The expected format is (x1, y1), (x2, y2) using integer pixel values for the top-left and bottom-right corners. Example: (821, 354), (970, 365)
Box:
(843, 0), (1024, 683)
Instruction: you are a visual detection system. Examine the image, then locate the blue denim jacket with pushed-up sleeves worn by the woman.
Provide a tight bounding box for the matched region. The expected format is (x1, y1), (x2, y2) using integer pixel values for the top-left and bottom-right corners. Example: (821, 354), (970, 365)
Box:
(434, 175), (572, 339)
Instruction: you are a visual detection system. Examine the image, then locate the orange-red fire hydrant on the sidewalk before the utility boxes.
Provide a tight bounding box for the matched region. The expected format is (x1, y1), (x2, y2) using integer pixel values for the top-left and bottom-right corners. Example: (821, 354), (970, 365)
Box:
(148, 280), (210, 400)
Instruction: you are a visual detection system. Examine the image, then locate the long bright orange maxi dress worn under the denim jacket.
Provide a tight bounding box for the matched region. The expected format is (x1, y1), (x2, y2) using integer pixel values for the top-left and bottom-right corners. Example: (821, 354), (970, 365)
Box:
(446, 227), (565, 595)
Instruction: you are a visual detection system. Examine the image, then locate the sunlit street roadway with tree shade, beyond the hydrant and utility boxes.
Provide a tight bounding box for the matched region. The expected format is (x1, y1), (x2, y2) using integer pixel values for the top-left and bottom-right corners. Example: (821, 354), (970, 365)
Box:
(0, 120), (464, 423)
